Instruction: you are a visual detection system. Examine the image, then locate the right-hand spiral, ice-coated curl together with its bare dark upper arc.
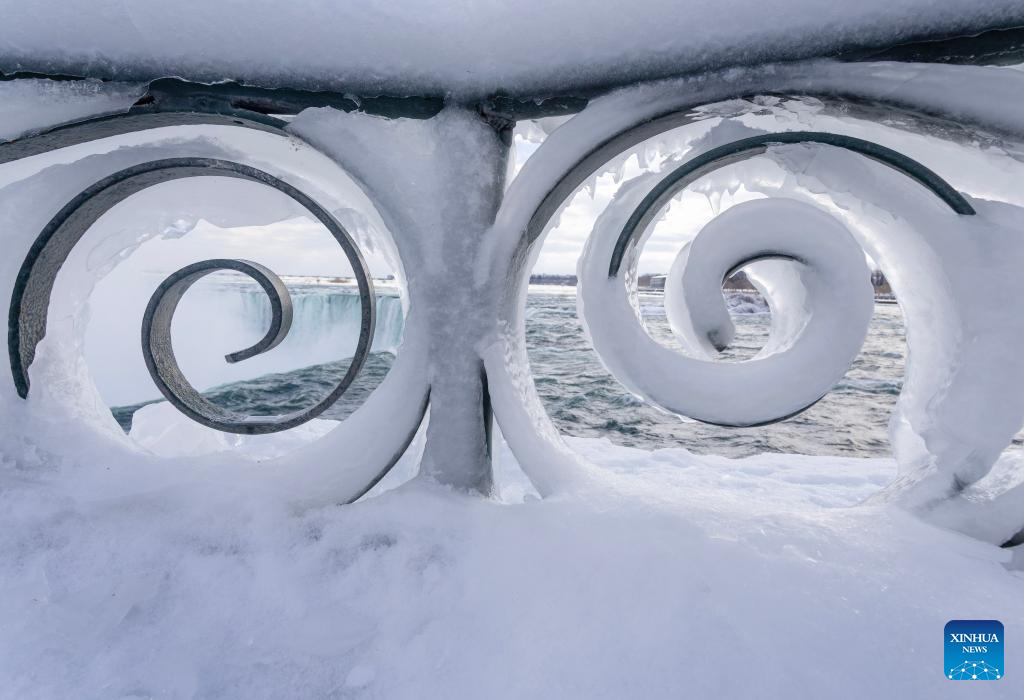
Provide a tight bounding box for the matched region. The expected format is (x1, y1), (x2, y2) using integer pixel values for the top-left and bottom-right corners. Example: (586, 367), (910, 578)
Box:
(578, 131), (975, 427)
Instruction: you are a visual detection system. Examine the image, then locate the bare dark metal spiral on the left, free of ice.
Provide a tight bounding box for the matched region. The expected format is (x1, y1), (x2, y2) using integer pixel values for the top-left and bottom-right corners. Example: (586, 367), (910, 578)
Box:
(7, 158), (376, 434)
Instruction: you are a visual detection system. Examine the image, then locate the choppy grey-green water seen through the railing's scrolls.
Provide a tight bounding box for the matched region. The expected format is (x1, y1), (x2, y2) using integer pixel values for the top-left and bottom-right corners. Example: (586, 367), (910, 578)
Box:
(114, 290), (905, 456)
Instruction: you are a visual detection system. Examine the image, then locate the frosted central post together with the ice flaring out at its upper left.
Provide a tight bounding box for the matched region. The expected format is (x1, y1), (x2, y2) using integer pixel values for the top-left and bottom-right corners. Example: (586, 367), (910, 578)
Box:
(290, 104), (512, 493)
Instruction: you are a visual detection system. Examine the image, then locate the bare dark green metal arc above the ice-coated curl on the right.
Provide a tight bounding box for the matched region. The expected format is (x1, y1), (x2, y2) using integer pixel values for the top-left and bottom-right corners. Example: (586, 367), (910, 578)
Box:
(608, 131), (975, 277)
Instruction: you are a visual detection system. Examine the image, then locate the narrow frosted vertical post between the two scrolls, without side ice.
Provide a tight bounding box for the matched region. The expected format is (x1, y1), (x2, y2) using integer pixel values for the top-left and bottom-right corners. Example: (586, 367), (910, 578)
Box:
(393, 108), (511, 493)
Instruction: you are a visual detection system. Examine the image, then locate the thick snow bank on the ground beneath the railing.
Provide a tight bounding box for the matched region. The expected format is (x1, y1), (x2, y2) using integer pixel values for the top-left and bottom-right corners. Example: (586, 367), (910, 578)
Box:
(0, 425), (1024, 700)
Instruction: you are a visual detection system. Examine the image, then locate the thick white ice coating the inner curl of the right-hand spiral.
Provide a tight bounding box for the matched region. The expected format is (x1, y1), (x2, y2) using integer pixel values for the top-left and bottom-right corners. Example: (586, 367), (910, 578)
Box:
(578, 196), (872, 426)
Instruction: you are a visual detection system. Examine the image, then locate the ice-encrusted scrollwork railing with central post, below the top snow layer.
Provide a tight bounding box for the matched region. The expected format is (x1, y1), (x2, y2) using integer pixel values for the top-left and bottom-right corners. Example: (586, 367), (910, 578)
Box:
(0, 30), (1024, 543)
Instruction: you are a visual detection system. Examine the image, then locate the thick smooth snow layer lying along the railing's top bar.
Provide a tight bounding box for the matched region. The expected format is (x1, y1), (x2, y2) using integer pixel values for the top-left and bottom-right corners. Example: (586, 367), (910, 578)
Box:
(0, 0), (1024, 95)
